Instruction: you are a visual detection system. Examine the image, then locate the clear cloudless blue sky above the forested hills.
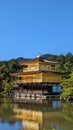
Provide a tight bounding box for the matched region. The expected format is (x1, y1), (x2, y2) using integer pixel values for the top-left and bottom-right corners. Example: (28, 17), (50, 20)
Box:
(0, 0), (73, 60)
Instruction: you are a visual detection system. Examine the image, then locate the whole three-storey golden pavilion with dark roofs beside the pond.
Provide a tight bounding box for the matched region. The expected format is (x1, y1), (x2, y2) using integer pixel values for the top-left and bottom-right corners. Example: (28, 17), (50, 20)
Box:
(13, 57), (62, 99)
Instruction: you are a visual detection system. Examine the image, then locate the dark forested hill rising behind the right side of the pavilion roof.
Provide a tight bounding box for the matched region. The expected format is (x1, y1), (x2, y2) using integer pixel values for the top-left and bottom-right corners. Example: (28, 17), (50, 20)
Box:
(41, 52), (73, 73)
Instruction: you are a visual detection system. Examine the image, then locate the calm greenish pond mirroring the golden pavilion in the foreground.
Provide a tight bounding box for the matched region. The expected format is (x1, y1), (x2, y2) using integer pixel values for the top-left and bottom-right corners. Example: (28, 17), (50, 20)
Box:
(0, 98), (73, 130)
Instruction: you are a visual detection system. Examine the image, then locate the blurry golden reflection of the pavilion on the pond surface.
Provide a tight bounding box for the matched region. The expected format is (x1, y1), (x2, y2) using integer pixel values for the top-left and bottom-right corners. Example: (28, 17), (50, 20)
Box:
(13, 100), (62, 130)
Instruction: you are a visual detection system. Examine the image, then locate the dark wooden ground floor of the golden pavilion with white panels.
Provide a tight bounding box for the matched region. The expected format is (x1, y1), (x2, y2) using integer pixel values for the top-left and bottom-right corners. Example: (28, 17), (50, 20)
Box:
(14, 82), (61, 100)
